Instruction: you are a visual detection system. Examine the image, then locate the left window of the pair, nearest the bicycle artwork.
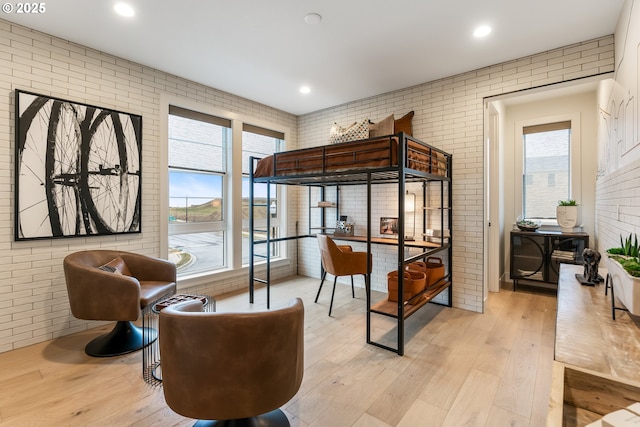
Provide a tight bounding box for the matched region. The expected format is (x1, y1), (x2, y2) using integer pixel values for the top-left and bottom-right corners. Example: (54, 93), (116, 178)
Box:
(168, 106), (231, 276)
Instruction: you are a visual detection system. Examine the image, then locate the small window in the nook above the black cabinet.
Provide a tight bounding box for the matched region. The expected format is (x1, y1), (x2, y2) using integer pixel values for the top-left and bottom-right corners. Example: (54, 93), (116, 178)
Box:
(522, 121), (571, 219)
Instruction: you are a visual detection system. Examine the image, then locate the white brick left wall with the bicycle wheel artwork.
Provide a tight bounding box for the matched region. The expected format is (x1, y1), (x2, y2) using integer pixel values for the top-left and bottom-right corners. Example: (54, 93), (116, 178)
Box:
(0, 20), (297, 352)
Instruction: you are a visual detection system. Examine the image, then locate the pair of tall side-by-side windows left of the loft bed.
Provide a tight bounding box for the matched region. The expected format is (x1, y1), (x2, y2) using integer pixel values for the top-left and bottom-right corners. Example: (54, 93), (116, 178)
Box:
(168, 106), (284, 278)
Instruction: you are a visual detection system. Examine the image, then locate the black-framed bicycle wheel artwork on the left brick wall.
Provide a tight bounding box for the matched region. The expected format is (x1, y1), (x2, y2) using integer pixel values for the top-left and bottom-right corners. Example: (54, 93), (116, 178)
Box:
(15, 90), (142, 240)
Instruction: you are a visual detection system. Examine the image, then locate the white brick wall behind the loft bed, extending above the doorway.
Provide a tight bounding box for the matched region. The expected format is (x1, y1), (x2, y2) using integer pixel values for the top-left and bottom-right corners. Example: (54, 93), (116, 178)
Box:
(298, 36), (614, 311)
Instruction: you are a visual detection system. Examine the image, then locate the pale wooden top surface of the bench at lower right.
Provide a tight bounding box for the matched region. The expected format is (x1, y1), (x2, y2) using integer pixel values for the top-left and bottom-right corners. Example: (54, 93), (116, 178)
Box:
(555, 264), (640, 381)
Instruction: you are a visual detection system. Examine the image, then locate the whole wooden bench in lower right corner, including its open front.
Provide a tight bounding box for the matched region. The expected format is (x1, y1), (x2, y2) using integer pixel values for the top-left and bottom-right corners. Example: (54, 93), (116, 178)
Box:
(547, 264), (640, 427)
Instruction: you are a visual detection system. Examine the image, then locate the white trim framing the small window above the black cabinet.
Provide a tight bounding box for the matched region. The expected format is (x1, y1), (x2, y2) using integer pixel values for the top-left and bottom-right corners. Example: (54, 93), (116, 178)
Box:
(513, 112), (582, 226)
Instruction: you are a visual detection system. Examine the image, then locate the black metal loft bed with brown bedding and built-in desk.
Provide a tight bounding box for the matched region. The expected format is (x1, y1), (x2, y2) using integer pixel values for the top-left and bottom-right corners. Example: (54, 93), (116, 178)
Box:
(249, 132), (453, 355)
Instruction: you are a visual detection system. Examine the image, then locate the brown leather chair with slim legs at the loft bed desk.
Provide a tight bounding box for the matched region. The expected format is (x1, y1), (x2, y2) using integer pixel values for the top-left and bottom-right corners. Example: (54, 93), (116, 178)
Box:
(315, 234), (373, 316)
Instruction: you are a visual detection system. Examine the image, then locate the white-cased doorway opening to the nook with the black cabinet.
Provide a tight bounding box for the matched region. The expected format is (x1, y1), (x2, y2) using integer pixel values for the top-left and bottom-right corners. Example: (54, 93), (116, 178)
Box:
(483, 76), (610, 299)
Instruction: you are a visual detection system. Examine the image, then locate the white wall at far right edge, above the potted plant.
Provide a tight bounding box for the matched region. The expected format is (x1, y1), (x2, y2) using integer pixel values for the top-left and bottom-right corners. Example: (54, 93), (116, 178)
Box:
(595, 0), (640, 252)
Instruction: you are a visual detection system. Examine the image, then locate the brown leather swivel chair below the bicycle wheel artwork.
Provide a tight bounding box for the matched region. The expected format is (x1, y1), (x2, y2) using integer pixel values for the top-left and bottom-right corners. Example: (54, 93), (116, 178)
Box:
(63, 250), (176, 357)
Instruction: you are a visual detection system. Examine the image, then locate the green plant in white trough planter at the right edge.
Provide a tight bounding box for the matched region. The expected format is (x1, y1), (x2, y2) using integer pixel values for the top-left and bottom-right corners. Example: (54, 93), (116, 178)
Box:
(607, 234), (640, 315)
